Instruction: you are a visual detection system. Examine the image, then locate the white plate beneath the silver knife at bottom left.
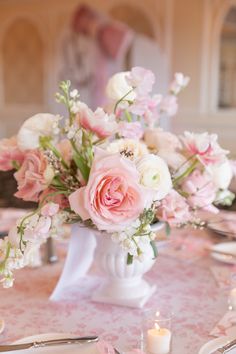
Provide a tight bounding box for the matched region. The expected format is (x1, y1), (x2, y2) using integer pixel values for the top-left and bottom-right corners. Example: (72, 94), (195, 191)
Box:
(11, 333), (99, 354)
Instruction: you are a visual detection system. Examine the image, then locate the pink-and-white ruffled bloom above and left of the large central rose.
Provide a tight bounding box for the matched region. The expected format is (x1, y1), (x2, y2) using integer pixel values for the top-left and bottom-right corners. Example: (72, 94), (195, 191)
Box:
(77, 103), (117, 139)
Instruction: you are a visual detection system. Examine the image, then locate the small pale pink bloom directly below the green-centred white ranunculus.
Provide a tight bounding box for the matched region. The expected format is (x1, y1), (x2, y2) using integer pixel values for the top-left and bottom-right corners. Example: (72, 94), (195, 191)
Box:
(156, 190), (191, 226)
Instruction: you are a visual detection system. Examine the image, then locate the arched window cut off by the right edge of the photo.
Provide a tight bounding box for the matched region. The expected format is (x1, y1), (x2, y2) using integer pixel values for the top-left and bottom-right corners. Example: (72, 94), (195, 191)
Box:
(218, 7), (236, 108)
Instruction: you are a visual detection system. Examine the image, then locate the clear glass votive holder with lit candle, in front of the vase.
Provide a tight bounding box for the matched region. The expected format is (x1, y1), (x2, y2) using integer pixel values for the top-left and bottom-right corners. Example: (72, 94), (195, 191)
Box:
(141, 310), (173, 354)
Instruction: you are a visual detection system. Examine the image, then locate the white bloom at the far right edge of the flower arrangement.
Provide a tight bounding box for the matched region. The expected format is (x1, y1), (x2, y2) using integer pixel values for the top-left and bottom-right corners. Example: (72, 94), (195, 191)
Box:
(207, 160), (233, 189)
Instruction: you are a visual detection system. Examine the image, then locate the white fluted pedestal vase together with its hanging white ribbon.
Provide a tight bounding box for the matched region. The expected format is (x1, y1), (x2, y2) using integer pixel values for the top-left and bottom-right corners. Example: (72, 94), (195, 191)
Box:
(50, 223), (163, 308)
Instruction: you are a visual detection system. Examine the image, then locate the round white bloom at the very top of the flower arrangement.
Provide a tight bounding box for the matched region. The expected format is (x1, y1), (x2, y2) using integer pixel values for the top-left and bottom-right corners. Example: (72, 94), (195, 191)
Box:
(106, 71), (136, 101)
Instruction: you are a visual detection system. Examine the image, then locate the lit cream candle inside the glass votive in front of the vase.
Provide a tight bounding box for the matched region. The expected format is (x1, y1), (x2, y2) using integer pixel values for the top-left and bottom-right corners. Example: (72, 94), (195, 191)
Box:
(147, 323), (171, 354)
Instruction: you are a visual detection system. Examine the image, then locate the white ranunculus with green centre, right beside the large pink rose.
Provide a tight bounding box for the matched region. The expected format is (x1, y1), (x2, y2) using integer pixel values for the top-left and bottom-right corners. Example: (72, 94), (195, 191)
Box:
(136, 154), (172, 200)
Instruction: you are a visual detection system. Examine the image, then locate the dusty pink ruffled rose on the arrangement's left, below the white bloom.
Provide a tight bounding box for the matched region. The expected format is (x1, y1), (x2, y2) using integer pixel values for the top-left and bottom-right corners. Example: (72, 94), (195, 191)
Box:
(14, 150), (53, 202)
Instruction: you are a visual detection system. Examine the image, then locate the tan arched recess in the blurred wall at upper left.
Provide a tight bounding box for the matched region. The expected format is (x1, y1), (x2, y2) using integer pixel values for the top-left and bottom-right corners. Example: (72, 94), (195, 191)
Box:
(2, 19), (43, 105)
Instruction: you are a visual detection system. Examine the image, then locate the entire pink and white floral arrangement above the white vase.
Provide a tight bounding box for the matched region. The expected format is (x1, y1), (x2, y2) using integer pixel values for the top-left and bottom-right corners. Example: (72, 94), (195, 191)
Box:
(0, 67), (233, 287)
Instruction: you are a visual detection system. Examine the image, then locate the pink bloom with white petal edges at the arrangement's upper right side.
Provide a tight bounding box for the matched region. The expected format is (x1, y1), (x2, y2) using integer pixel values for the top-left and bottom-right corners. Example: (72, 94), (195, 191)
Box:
(182, 132), (228, 166)
